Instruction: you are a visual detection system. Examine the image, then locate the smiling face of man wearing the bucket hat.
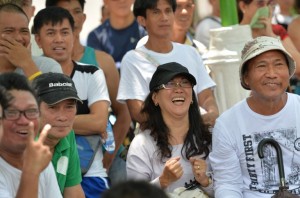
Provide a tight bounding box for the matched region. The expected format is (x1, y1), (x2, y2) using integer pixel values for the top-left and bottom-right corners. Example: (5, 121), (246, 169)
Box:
(244, 50), (289, 101)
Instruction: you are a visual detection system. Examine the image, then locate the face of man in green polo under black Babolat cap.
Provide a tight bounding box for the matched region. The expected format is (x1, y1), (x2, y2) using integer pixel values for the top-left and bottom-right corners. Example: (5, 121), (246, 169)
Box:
(40, 99), (76, 142)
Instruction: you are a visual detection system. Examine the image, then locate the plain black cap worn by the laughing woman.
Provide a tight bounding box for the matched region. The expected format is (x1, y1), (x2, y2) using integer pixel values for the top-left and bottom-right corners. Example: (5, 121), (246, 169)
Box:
(149, 62), (197, 91)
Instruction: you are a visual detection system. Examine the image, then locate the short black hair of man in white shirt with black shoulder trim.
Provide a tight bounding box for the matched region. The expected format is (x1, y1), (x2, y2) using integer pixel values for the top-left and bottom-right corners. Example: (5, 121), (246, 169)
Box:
(32, 6), (74, 34)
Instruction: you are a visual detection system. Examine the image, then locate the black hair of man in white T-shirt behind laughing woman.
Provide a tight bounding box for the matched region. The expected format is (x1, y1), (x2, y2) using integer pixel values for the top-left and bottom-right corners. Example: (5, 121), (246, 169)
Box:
(133, 0), (177, 18)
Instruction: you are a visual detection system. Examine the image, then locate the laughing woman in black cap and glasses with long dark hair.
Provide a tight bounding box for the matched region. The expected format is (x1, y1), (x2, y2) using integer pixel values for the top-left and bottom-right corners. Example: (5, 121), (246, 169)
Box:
(127, 62), (213, 195)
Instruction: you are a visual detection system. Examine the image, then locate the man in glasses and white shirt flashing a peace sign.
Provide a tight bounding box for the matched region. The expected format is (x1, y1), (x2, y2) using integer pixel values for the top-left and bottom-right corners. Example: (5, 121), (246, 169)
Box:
(0, 73), (62, 198)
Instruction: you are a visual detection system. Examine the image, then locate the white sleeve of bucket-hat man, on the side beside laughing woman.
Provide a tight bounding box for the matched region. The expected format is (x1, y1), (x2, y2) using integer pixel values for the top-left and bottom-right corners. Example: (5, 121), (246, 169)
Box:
(209, 120), (243, 198)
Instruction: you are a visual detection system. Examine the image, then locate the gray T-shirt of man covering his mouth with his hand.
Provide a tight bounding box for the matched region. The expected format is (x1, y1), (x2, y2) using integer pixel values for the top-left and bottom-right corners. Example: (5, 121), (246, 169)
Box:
(15, 56), (63, 74)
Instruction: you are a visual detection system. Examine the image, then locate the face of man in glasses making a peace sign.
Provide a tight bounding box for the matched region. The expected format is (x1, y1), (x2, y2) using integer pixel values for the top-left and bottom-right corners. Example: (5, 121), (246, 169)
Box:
(0, 90), (39, 154)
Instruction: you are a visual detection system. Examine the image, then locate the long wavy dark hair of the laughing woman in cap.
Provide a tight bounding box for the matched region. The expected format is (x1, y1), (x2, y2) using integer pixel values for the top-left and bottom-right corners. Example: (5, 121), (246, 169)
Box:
(141, 90), (211, 162)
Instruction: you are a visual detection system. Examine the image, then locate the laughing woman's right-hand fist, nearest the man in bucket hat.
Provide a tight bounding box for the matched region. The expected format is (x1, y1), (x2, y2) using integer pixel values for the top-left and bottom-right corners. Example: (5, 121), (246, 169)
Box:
(190, 157), (209, 187)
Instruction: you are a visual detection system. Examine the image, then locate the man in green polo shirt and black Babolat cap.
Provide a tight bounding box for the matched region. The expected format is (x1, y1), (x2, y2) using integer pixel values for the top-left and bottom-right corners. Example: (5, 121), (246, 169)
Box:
(32, 73), (85, 198)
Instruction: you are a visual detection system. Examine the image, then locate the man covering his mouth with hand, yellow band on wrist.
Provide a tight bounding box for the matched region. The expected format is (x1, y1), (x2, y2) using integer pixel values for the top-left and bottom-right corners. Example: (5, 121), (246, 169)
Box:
(0, 0), (62, 80)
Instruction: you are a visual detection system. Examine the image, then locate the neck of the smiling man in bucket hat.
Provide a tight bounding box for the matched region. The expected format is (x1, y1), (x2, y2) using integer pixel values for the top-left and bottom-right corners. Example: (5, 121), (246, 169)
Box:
(247, 93), (287, 116)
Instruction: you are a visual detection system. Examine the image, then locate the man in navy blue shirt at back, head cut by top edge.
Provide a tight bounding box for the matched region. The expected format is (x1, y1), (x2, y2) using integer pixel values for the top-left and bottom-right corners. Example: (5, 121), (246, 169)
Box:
(87, 0), (147, 69)
